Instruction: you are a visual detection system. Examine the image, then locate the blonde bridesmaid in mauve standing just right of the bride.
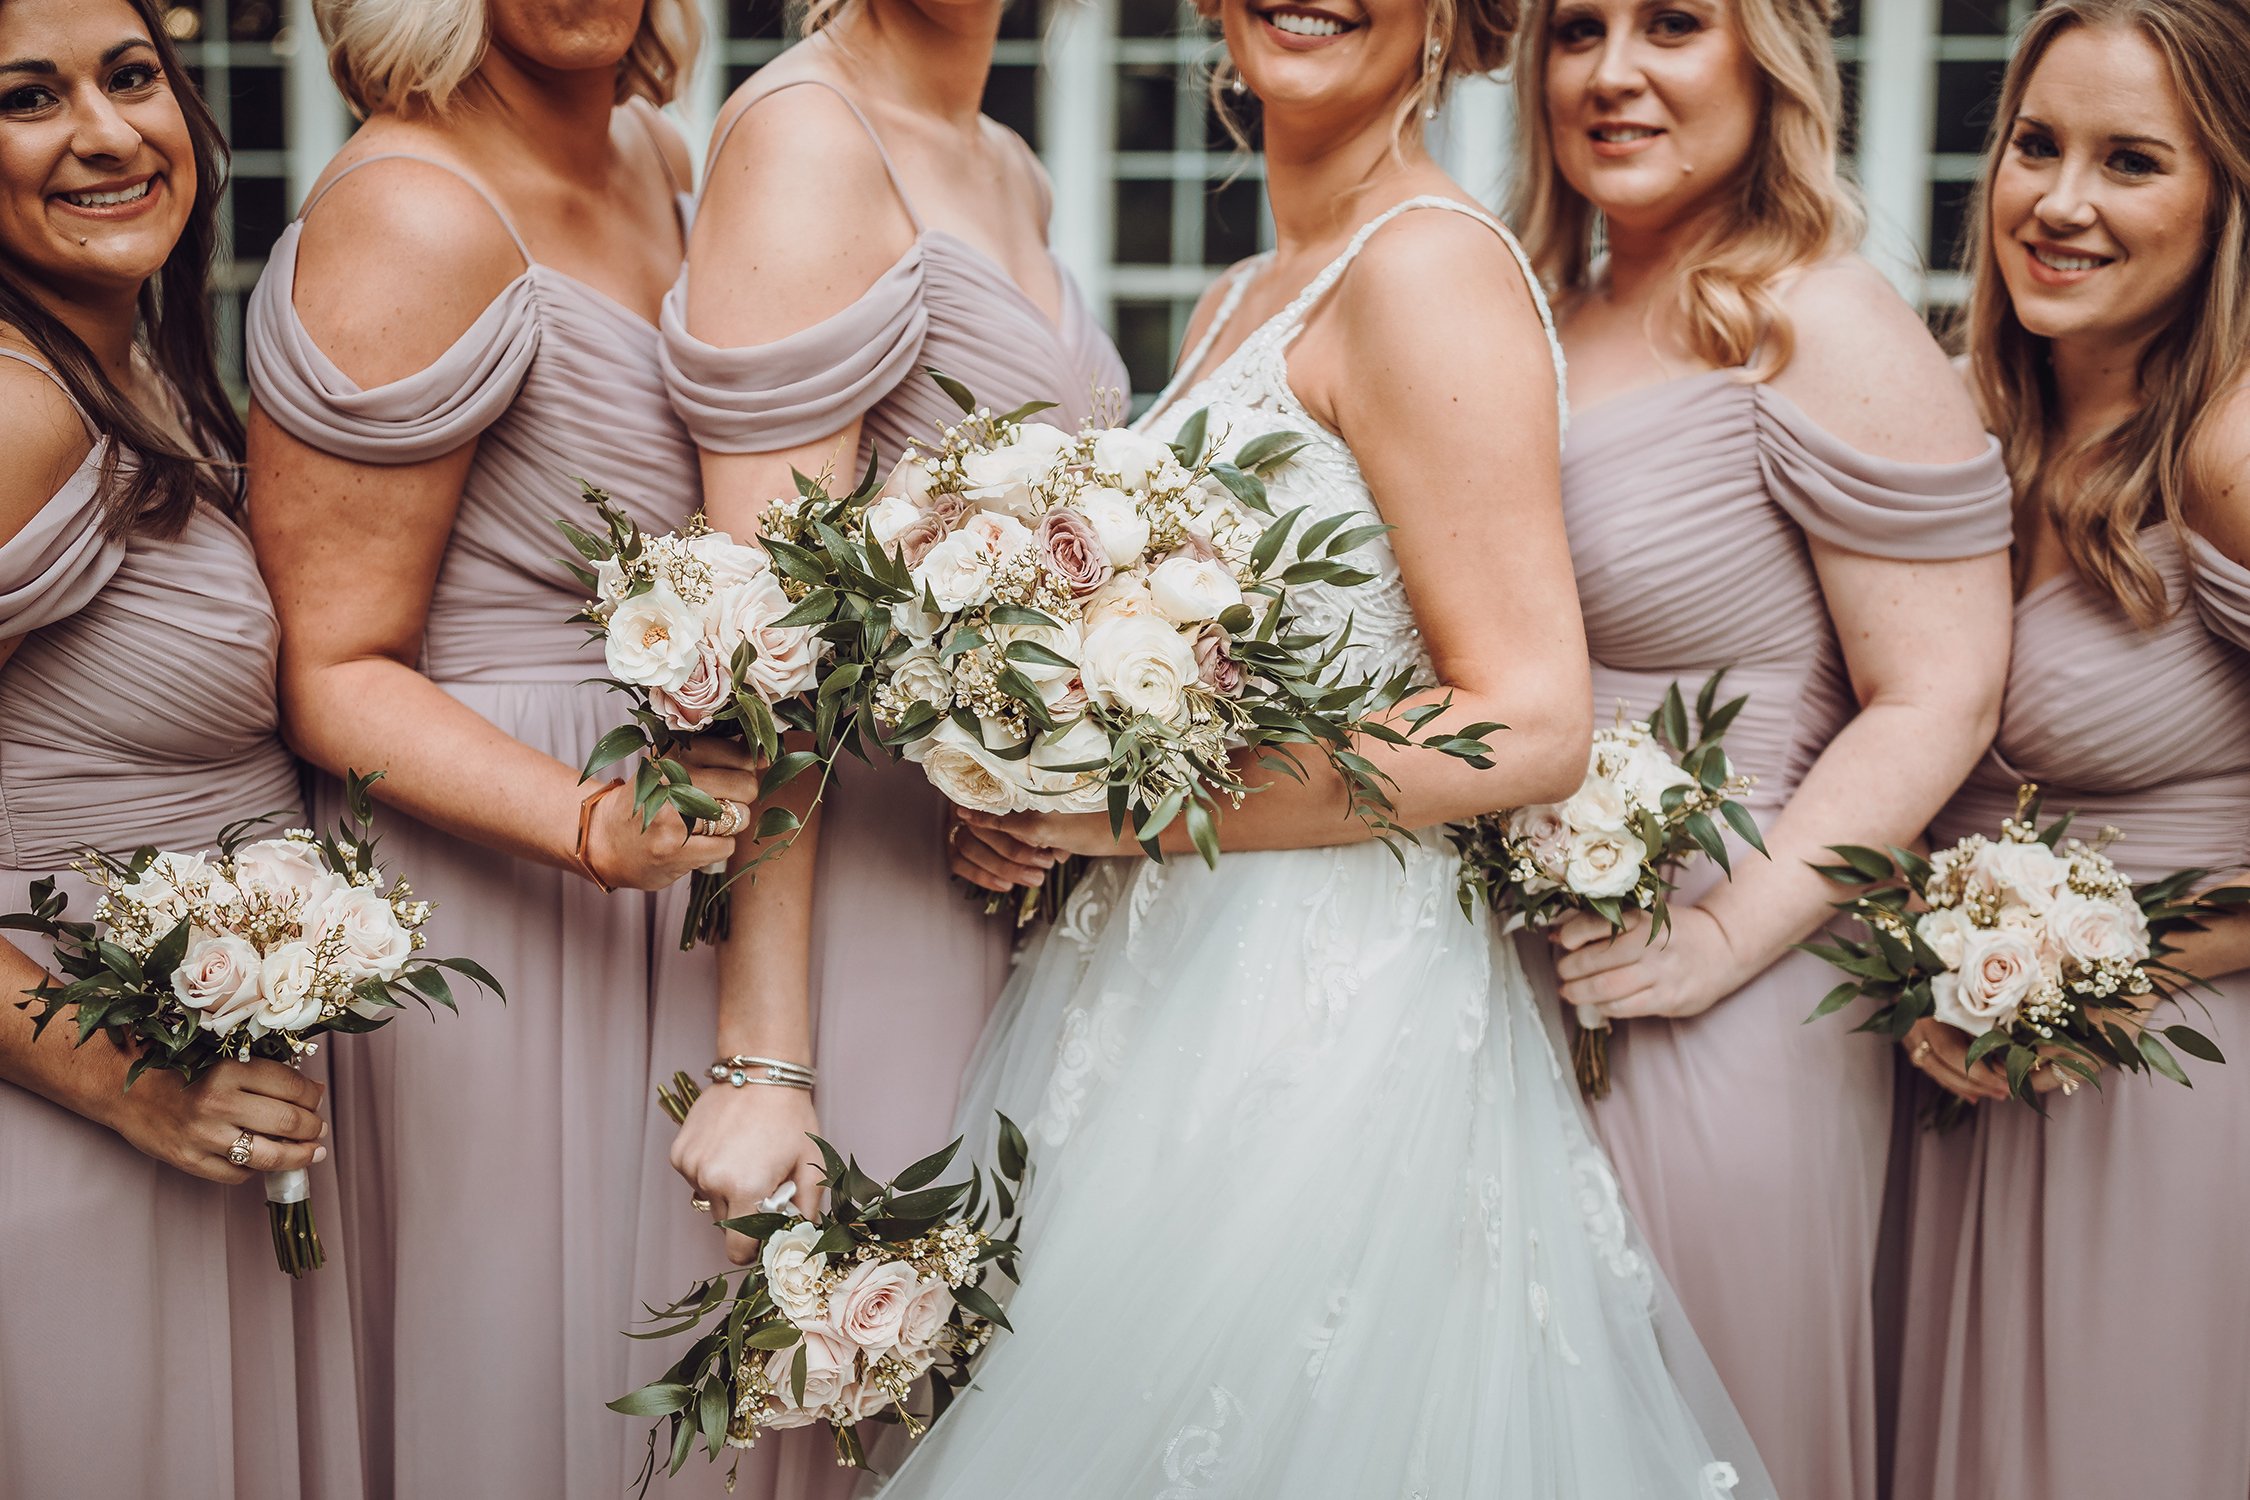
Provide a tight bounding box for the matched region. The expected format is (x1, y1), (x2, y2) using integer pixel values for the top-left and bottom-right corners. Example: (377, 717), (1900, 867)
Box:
(1512, 0), (2009, 1500)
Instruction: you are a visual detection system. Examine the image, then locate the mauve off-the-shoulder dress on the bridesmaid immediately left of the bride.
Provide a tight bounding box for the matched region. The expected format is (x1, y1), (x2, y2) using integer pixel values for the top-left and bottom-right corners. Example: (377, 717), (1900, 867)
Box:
(664, 79), (1127, 1176)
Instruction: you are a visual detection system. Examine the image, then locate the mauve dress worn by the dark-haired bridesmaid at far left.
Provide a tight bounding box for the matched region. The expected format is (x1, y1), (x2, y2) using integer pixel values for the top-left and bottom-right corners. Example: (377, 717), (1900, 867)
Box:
(0, 349), (360, 1500)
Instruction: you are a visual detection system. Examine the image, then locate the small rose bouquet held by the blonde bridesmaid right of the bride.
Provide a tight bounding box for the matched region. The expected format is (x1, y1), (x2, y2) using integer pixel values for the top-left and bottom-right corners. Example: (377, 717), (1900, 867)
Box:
(1449, 670), (1766, 1100)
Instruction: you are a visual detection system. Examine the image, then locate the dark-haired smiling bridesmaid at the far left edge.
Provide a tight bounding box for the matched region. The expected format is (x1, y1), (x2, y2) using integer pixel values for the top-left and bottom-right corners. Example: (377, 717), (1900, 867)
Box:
(0, 0), (360, 1500)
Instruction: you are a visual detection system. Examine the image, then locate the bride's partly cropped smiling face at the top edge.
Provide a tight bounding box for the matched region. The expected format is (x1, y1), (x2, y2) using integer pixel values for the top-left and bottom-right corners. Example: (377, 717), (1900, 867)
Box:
(1220, 0), (1429, 126)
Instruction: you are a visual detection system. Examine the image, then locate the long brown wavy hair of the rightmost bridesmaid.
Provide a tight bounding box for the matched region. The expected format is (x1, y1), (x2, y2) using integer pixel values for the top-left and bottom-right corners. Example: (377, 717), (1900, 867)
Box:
(1958, 0), (2250, 630)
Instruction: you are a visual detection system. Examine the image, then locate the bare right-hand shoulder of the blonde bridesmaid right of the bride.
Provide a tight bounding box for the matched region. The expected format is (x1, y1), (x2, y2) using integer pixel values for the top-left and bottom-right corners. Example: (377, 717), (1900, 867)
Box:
(1773, 254), (1985, 463)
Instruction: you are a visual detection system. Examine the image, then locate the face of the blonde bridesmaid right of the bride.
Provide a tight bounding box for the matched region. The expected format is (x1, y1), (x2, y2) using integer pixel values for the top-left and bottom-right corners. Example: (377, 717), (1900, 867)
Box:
(1544, 0), (1764, 229)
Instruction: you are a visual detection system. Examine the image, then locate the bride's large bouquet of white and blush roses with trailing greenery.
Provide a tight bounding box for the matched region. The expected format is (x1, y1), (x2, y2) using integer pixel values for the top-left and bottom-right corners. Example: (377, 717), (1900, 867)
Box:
(765, 376), (1501, 861)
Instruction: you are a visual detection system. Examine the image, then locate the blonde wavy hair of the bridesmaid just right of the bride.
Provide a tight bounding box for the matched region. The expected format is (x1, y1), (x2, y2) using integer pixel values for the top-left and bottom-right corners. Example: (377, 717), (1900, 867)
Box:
(1508, 0), (1868, 380)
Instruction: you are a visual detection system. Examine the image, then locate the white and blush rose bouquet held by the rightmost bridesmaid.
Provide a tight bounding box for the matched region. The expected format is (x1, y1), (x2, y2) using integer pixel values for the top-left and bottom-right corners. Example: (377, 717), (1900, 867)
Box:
(1802, 785), (2250, 1129)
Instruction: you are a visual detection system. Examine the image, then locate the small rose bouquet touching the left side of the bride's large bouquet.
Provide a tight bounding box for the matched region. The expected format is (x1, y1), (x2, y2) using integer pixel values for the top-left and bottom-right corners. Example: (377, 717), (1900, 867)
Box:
(556, 481), (826, 947)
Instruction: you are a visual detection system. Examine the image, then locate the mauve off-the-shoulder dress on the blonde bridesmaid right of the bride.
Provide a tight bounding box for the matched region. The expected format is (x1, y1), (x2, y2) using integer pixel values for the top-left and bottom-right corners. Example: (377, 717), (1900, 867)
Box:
(1521, 371), (2009, 1500)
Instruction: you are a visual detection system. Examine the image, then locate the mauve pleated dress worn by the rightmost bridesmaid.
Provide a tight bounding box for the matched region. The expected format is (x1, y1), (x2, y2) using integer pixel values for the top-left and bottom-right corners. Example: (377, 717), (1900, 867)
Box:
(1892, 524), (2250, 1500)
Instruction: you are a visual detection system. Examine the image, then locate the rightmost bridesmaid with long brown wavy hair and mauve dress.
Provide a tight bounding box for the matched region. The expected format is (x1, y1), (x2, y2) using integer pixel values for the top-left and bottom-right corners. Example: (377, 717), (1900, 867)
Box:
(1895, 0), (2250, 1500)
